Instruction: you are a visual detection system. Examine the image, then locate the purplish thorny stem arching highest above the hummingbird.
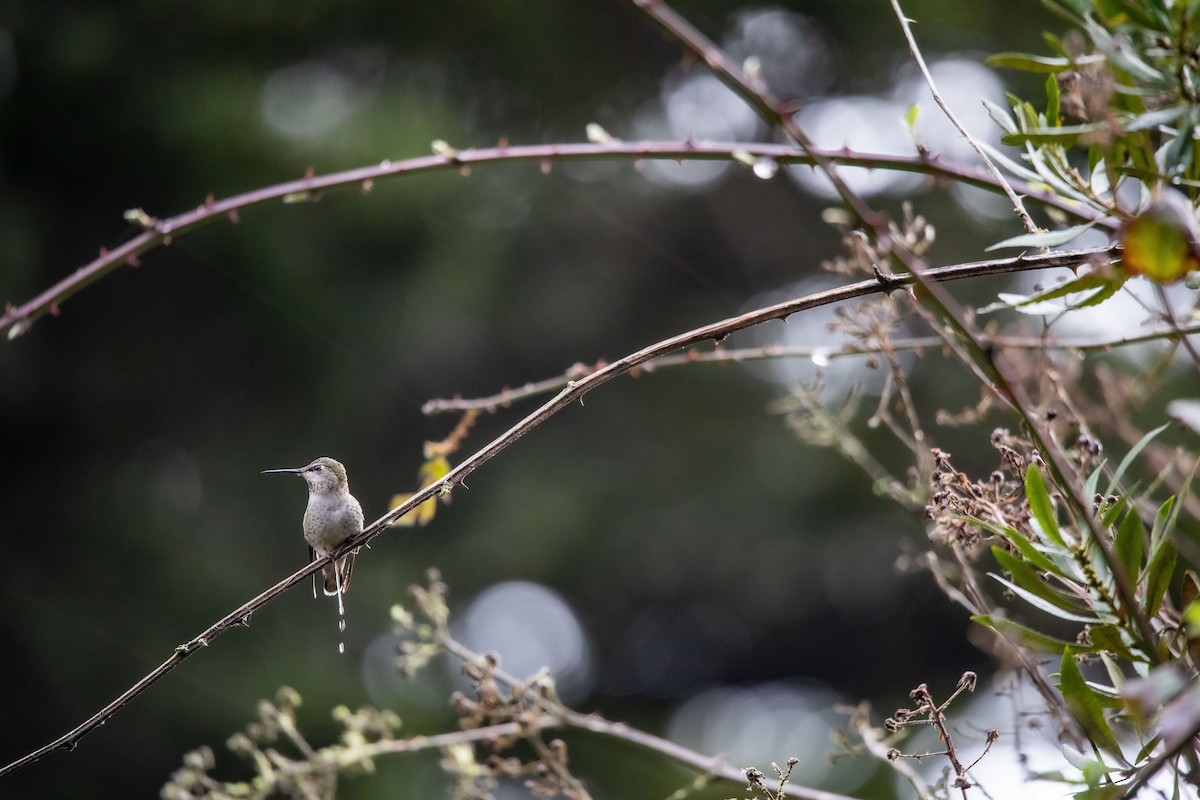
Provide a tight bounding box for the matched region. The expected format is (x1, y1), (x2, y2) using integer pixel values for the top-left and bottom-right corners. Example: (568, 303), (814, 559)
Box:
(0, 140), (1117, 339)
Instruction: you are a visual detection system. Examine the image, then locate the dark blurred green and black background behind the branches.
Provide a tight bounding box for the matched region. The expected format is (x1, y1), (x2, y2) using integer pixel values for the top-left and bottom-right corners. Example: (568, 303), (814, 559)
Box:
(0, 0), (1057, 798)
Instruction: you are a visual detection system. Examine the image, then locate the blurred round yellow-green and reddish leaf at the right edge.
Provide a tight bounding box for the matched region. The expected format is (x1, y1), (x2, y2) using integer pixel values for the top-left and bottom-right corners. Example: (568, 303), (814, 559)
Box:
(1121, 188), (1200, 283)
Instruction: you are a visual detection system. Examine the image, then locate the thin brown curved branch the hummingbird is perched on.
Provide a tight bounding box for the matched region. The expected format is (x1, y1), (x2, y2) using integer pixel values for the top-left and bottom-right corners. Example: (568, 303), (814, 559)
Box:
(0, 248), (1115, 776)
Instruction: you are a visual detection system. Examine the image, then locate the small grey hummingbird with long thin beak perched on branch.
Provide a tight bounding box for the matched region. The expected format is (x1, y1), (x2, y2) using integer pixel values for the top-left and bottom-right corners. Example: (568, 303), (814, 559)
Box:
(263, 457), (362, 603)
